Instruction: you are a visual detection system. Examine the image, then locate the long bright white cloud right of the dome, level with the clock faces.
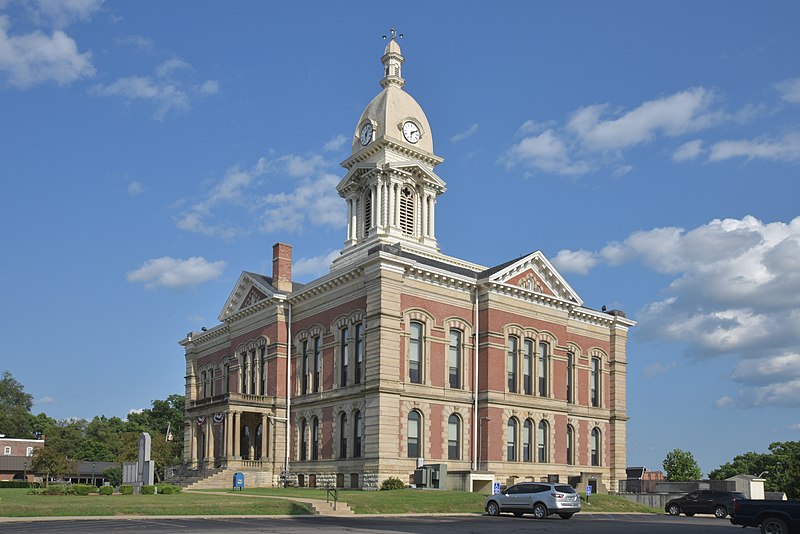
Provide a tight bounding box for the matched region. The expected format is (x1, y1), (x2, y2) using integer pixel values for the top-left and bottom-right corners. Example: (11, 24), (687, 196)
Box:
(567, 87), (715, 150)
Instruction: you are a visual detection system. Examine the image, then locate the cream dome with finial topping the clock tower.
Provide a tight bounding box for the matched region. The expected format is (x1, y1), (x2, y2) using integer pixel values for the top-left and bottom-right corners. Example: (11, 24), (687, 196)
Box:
(352, 37), (433, 154)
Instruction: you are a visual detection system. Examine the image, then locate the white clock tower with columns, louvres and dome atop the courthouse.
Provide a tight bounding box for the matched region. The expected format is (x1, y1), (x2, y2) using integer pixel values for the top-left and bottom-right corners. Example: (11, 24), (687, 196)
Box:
(332, 30), (445, 269)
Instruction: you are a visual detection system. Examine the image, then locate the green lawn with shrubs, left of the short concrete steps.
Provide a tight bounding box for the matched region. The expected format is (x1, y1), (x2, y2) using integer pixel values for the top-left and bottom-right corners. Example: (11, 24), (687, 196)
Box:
(0, 489), (312, 517)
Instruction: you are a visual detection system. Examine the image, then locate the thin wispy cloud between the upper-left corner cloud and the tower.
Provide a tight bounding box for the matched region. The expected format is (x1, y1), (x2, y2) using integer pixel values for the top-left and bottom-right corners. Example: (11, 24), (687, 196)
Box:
(91, 57), (219, 120)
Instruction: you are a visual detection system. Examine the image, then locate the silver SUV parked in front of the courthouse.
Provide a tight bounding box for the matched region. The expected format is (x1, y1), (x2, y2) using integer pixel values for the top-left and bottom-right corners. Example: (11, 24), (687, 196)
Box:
(483, 482), (581, 519)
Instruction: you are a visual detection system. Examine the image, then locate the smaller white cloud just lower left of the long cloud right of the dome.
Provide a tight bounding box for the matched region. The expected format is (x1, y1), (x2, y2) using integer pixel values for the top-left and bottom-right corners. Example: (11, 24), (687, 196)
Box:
(501, 130), (591, 175)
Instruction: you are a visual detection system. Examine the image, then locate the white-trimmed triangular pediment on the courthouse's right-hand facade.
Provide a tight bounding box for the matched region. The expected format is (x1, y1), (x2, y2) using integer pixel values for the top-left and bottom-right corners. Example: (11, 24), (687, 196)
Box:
(480, 250), (583, 306)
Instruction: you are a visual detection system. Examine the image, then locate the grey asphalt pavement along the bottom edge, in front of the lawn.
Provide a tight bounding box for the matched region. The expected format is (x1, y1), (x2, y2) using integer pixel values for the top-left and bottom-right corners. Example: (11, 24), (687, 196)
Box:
(0, 513), (758, 534)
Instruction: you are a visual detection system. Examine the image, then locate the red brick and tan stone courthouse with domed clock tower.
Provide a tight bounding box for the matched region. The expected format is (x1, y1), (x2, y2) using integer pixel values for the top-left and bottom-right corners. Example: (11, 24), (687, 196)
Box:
(181, 35), (634, 491)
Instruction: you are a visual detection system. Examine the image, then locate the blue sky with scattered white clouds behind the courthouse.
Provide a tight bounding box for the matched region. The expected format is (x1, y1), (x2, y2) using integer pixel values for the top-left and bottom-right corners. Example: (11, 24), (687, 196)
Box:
(0, 0), (800, 478)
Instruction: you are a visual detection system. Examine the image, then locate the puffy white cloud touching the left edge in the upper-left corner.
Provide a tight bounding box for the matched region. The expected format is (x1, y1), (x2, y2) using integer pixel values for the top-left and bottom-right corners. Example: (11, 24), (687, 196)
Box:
(0, 14), (95, 88)
